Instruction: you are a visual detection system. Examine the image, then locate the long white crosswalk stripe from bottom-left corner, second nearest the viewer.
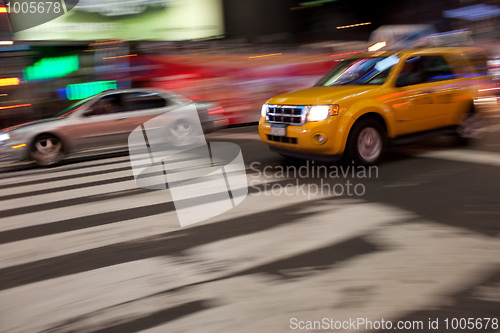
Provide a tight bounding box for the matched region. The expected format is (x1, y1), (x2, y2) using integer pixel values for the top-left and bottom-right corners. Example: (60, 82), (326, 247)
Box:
(0, 200), (406, 332)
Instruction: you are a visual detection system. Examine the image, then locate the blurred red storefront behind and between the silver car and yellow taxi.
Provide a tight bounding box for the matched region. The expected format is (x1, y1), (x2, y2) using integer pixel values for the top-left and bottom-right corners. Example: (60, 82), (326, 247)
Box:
(141, 53), (335, 124)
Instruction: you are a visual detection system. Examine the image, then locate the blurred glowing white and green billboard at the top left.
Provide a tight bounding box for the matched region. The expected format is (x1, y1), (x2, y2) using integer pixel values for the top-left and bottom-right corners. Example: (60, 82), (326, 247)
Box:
(11, 0), (224, 41)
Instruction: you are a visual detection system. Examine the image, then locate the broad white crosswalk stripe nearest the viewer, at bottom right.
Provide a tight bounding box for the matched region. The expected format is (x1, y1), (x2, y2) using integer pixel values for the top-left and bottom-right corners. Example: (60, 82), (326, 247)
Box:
(144, 223), (498, 333)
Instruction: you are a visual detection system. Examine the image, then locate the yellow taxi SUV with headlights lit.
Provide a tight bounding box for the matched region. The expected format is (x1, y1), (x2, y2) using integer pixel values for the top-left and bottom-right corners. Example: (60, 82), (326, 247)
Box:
(259, 47), (486, 165)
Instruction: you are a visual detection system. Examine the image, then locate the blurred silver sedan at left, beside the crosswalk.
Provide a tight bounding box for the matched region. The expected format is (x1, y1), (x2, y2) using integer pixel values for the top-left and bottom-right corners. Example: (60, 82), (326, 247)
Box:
(0, 89), (223, 166)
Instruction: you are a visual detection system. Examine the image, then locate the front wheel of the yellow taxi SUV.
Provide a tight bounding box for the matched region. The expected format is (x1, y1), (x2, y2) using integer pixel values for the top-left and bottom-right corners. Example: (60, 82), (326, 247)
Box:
(347, 118), (386, 165)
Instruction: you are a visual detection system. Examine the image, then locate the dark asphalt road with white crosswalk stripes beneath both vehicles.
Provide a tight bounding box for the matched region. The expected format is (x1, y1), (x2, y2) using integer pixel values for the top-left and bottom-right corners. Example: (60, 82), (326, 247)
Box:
(0, 100), (500, 333)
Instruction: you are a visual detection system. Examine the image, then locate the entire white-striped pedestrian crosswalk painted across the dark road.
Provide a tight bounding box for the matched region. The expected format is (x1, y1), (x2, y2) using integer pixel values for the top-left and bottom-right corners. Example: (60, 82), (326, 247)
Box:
(0, 141), (500, 333)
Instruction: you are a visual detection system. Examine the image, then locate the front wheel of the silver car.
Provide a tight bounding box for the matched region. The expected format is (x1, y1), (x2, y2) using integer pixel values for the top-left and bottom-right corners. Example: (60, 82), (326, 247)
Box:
(30, 134), (64, 166)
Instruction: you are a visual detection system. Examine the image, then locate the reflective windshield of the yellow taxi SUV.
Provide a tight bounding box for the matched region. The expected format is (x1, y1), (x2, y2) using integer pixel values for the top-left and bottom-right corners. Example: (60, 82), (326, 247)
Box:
(316, 55), (399, 87)
